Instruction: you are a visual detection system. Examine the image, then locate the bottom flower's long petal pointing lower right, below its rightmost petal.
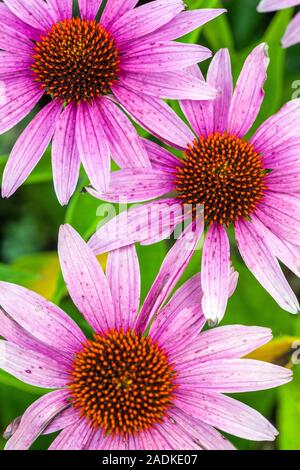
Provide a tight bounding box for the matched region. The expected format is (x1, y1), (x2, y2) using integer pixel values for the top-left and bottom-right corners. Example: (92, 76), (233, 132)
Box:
(177, 391), (278, 441)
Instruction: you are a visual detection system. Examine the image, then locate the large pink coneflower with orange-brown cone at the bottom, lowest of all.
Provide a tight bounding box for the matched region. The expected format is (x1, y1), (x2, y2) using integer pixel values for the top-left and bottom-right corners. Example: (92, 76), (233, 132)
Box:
(0, 226), (291, 450)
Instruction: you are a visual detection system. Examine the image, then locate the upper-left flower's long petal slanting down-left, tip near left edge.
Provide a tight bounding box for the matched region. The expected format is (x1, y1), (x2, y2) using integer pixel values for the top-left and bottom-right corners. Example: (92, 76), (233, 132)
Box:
(2, 101), (62, 197)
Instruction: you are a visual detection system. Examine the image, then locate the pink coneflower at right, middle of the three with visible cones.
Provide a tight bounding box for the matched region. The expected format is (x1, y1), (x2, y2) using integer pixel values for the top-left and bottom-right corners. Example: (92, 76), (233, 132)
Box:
(89, 44), (300, 322)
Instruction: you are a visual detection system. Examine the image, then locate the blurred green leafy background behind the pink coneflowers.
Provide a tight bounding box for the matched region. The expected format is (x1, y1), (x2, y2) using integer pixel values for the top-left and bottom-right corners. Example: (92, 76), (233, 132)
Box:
(0, 0), (300, 450)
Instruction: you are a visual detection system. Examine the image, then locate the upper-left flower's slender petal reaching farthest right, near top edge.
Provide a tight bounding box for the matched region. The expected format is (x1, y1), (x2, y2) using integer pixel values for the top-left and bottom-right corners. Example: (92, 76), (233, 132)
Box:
(144, 8), (226, 42)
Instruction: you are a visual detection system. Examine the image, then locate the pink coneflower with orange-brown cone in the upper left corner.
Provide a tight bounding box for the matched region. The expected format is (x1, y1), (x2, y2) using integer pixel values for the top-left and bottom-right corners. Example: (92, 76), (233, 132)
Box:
(0, 0), (225, 205)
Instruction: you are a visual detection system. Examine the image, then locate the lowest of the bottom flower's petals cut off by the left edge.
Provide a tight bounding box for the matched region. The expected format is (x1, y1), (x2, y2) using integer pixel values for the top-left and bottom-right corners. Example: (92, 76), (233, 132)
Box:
(0, 340), (68, 389)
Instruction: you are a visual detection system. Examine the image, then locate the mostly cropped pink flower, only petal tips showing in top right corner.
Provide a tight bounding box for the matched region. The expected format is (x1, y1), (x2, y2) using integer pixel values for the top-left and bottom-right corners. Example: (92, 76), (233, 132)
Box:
(257, 0), (300, 47)
